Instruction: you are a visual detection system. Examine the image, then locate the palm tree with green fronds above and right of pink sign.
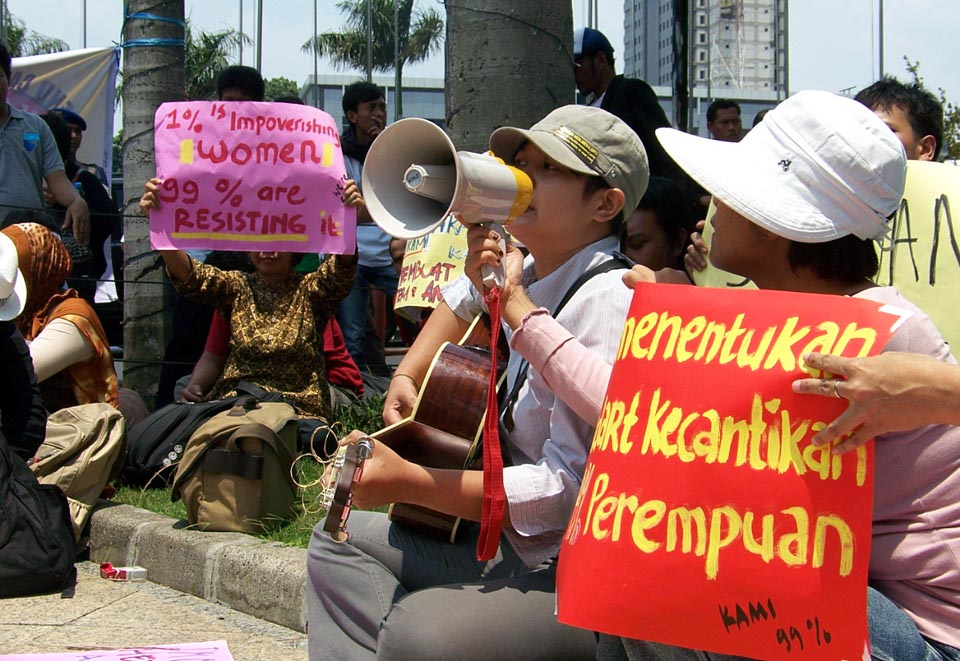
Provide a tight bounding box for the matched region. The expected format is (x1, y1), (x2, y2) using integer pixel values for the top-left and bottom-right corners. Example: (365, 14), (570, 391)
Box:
(303, 0), (443, 117)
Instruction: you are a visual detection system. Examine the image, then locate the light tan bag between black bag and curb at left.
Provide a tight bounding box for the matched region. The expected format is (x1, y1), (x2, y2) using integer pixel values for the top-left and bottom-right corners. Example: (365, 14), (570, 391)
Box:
(30, 403), (126, 541)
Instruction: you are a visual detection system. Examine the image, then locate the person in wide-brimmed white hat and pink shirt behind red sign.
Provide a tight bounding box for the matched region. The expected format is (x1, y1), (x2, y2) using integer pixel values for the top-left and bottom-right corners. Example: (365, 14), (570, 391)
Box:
(523, 92), (960, 659)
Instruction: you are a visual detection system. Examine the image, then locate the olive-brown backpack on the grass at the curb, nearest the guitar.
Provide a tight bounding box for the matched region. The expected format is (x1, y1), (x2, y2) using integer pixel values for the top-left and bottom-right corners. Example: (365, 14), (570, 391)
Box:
(171, 397), (298, 532)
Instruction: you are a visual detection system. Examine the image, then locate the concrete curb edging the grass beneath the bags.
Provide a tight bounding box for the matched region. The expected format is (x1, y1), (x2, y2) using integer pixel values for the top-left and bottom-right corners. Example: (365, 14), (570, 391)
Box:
(90, 500), (307, 632)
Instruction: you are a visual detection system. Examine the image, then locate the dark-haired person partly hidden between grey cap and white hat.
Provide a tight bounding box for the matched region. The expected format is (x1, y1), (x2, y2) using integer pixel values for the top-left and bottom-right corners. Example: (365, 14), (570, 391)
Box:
(620, 177), (695, 274)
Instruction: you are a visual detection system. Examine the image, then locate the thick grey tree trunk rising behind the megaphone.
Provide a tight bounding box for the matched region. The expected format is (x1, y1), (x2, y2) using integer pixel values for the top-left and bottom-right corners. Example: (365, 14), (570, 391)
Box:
(445, 0), (575, 151)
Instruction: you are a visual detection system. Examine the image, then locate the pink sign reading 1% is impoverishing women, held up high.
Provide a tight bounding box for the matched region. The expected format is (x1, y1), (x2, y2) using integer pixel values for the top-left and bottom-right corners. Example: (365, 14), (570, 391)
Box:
(150, 101), (356, 254)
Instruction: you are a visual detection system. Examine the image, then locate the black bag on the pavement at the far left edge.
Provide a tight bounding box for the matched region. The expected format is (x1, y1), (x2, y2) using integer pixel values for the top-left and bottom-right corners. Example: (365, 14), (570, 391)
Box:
(0, 433), (77, 597)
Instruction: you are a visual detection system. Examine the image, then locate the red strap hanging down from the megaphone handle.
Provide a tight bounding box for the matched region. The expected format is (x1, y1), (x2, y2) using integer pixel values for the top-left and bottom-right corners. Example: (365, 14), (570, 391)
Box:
(477, 287), (506, 562)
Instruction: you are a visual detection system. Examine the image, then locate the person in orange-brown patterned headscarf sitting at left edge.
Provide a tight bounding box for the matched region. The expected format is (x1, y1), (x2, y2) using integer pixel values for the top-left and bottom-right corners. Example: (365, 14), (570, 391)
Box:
(2, 223), (119, 411)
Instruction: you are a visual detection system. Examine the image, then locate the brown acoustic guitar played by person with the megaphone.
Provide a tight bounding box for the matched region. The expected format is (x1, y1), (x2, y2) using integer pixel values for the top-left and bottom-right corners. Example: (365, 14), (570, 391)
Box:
(324, 318), (506, 542)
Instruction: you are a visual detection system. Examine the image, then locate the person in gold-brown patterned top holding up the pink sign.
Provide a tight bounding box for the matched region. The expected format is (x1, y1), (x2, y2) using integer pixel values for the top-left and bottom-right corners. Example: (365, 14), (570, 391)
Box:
(140, 178), (359, 420)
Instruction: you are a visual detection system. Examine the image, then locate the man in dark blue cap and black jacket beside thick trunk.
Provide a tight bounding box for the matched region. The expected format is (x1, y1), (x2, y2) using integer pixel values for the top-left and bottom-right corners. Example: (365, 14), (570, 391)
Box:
(573, 28), (688, 196)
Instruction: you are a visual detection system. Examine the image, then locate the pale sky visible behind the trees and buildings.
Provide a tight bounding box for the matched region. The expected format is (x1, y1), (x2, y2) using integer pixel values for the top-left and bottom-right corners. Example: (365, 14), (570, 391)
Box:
(7, 0), (960, 108)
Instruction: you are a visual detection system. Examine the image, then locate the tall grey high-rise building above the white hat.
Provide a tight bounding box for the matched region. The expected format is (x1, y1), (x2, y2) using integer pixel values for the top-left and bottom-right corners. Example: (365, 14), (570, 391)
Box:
(622, 0), (788, 135)
